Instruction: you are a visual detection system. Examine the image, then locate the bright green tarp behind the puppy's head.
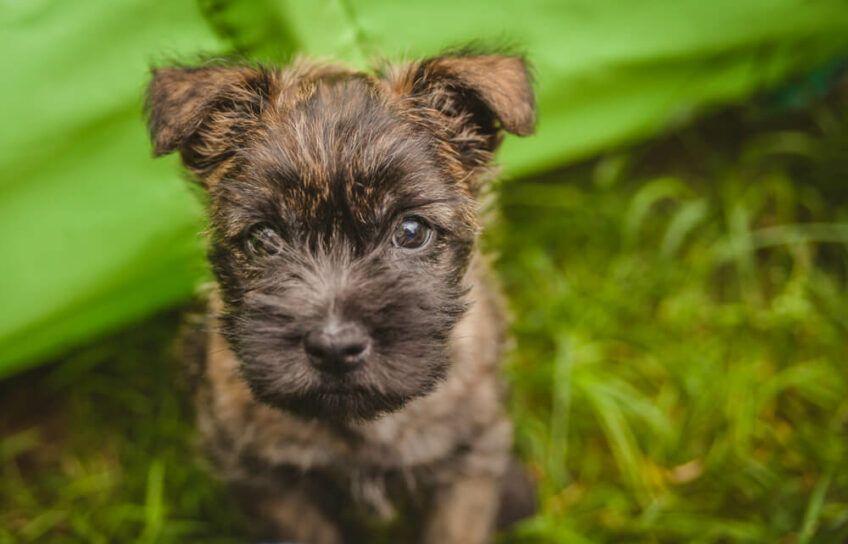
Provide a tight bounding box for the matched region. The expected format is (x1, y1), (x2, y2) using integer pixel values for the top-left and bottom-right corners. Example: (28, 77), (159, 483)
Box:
(0, 0), (848, 375)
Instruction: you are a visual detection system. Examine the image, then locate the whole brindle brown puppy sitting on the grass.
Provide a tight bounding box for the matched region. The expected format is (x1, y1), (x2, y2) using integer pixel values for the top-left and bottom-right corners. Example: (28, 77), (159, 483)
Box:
(142, 52), (535, 544)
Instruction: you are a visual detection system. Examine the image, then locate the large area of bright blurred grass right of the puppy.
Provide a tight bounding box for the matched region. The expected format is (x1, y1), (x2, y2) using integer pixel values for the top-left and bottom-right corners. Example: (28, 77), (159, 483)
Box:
(493, 84), (848, 543)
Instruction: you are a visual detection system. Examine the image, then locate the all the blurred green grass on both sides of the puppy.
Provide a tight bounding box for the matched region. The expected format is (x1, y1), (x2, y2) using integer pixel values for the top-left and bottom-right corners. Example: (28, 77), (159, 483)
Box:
(0, 86), (848, 544)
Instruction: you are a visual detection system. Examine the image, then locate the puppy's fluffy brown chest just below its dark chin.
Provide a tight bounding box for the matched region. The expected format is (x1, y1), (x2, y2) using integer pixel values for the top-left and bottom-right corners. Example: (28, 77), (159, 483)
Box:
(198, 328), (502, 474)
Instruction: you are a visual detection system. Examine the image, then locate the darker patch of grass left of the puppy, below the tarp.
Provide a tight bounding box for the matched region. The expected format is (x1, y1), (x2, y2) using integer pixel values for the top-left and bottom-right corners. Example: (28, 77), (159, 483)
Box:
(0, 313), (248, 544)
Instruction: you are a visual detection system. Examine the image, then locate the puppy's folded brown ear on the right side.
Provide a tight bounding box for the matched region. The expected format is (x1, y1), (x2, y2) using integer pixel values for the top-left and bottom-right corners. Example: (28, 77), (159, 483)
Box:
(387, 53), (536, 172)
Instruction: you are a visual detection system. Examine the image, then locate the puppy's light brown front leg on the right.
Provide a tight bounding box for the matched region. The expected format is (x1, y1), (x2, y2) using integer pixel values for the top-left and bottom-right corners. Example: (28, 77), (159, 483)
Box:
(423, 474), (500, 544)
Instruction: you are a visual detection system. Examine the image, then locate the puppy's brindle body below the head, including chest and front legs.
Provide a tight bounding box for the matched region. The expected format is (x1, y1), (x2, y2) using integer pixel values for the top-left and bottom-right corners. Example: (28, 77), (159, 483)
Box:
(197, 258), (512, 542)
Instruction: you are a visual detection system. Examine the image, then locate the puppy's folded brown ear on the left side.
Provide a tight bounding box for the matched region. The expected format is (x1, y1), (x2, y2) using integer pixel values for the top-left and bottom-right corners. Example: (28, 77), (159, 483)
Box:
(146, 66), (273, 187)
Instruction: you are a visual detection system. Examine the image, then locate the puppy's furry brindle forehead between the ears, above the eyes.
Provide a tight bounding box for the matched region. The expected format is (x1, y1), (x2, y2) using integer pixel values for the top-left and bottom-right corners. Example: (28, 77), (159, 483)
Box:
(245, 77), (455, 221)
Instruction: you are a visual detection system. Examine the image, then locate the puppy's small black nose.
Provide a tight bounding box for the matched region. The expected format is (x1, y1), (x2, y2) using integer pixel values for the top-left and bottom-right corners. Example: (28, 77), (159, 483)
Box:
(303, 323), (371, 373)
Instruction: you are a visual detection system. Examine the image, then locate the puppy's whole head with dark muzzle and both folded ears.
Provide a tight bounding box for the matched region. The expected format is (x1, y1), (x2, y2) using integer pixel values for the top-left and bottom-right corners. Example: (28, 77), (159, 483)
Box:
(149, 55), (534, 420)
